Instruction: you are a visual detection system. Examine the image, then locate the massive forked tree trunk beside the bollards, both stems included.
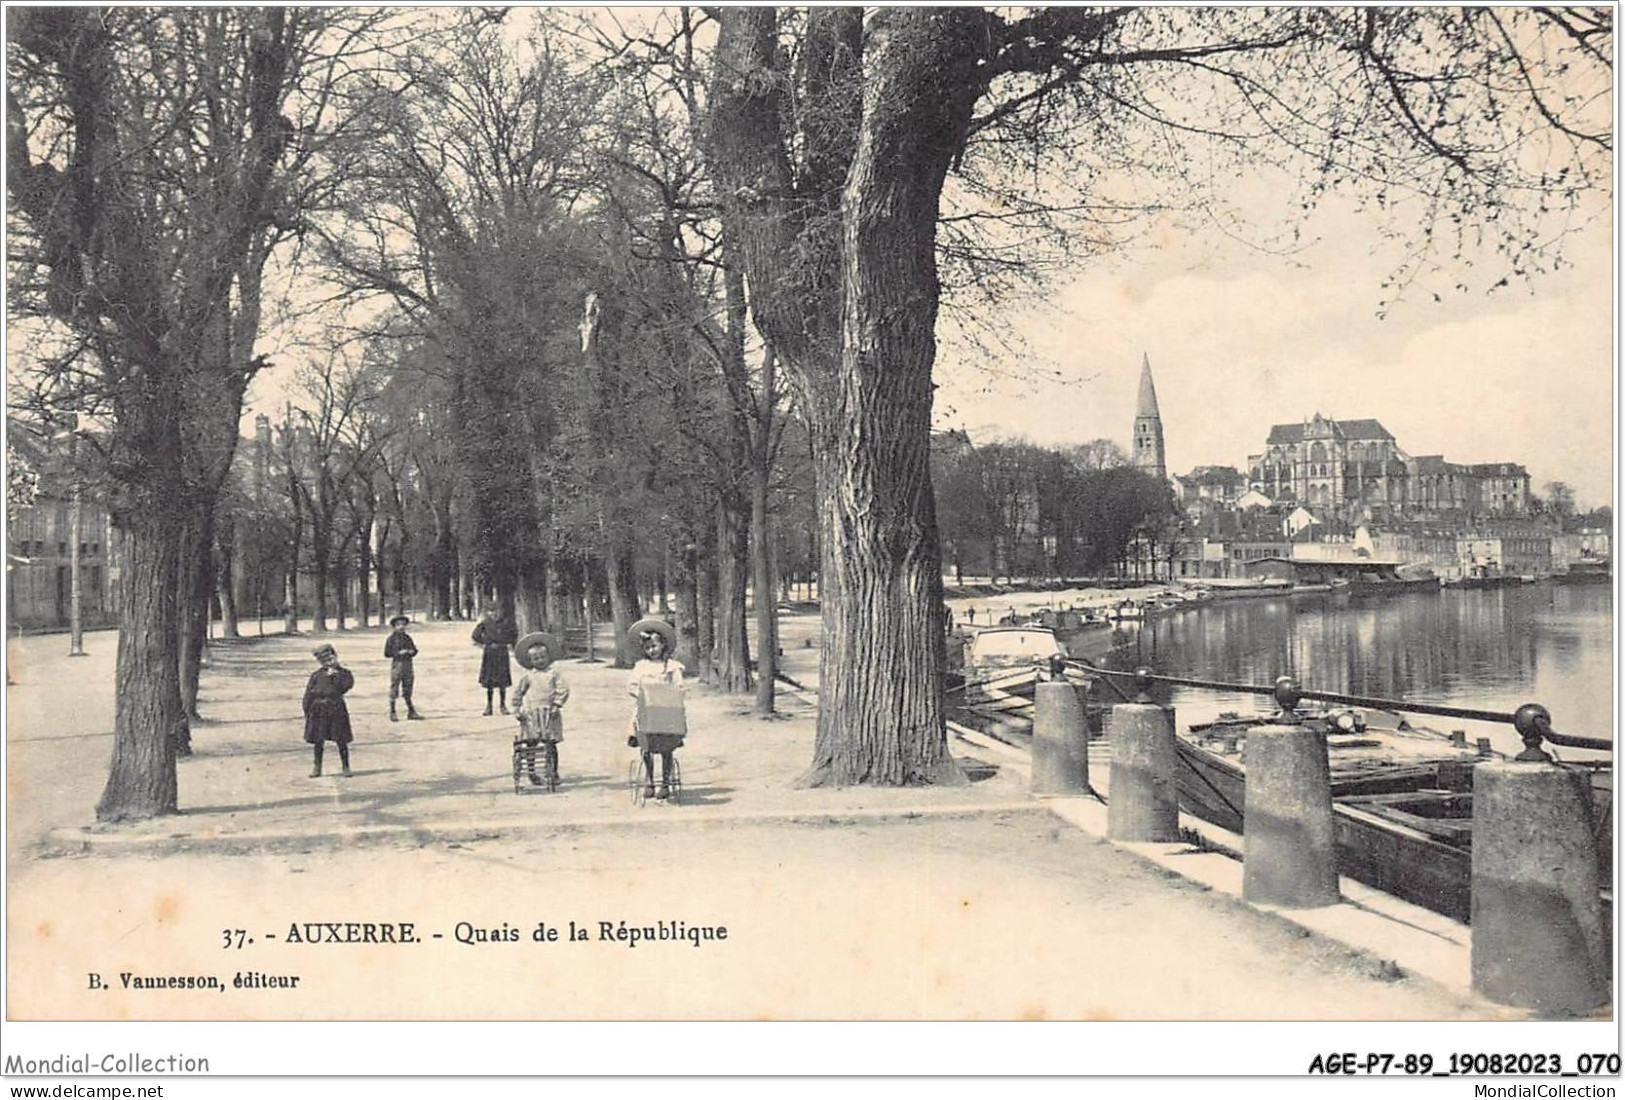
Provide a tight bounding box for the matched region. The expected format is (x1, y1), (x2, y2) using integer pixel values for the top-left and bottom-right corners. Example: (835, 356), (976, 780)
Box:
(712, 8), (988, 785)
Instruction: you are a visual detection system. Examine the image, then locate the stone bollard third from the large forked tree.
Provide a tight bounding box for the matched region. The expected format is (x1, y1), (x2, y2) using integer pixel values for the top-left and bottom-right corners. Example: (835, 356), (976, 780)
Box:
(1242, 676), (1339, 908)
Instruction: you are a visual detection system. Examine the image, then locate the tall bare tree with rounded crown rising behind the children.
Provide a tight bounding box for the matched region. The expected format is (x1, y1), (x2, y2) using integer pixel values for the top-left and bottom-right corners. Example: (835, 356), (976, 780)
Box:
(319, 11), (603, 627)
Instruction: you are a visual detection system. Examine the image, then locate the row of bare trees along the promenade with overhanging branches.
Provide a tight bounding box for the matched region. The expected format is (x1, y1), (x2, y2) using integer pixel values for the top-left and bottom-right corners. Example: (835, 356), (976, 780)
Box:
(7, 6), (1612, 819)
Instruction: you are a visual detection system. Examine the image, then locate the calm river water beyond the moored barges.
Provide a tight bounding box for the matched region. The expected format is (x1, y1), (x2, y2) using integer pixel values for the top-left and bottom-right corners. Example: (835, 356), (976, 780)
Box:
(1089, 583), (1614, 759)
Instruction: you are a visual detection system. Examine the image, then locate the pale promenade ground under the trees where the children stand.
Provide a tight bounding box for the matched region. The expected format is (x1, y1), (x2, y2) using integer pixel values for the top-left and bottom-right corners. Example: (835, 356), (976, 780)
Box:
(8, 616), (1025, 851)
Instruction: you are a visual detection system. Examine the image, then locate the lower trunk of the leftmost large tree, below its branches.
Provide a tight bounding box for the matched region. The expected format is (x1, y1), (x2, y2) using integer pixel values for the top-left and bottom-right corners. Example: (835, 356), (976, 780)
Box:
(96, 509), (184, 821)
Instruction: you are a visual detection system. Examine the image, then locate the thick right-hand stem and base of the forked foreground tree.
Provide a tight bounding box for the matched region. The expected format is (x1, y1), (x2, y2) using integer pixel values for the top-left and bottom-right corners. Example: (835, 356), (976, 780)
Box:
(808, 8), (975, 785)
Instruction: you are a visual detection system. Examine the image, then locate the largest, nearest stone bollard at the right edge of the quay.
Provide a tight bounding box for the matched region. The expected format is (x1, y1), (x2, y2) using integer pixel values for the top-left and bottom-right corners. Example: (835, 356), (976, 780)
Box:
(1472, 704), (1609, 1016)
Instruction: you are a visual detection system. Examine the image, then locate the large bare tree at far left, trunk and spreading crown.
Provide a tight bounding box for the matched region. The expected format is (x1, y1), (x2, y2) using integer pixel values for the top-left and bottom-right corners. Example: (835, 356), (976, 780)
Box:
(7, 8), (406, 821)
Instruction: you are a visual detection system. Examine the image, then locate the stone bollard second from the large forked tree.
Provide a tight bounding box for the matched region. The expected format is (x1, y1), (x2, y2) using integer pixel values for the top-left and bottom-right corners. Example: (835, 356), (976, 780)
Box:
(1107, 668), (1180, 842)
